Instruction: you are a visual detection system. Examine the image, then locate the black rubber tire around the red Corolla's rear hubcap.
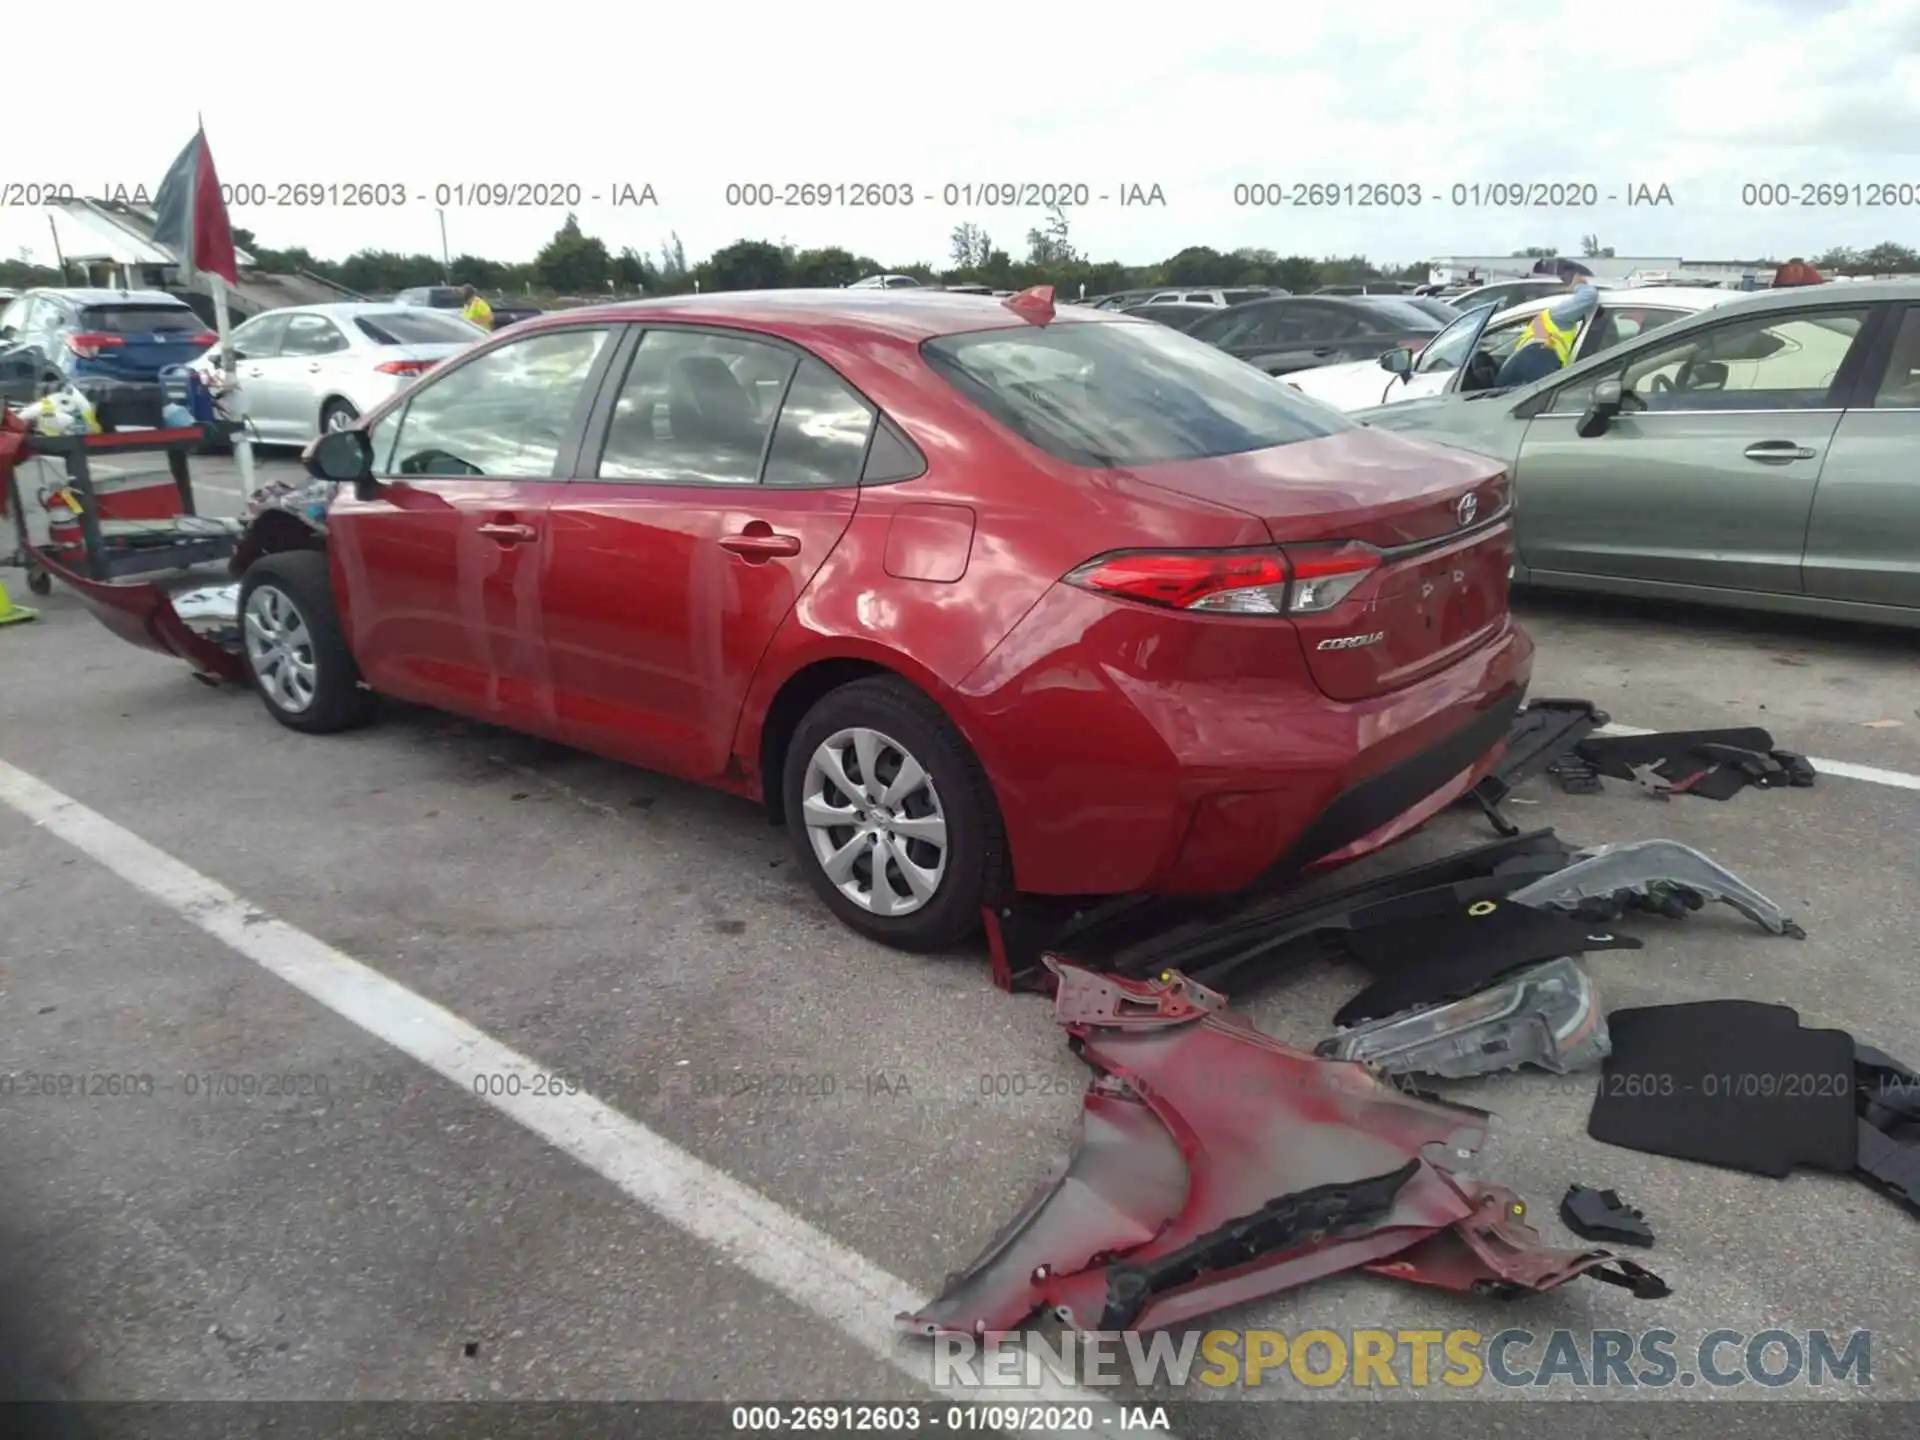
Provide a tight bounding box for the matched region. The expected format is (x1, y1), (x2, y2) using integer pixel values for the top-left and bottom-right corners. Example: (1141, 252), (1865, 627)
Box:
(780, 676), (1012, 952)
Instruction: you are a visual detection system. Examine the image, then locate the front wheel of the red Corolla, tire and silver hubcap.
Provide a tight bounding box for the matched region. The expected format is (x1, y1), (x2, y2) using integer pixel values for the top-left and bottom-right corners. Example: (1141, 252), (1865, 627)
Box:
(240, 549), (374, 735)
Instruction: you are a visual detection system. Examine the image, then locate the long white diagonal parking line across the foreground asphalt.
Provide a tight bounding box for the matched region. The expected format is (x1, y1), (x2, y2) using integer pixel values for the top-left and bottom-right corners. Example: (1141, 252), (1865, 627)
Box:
(0, 760), (1171, 1440)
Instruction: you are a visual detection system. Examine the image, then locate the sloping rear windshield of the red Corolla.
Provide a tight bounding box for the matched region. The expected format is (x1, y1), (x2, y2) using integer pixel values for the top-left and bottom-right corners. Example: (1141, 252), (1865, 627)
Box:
(922, 321), (1357, 467)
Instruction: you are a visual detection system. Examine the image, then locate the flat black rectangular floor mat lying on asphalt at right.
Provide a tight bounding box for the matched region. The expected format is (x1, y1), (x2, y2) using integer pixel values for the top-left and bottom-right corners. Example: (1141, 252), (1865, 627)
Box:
(1586, 1000), (1859, 1179)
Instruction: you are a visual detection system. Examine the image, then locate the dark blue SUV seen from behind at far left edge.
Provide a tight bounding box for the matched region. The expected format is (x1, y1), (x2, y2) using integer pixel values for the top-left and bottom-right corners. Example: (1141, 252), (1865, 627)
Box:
(0, 290), (217, 430)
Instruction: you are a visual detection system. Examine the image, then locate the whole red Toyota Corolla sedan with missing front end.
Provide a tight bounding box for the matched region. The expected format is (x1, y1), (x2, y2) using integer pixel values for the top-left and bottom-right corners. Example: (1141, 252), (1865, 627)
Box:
(240, 290), (1532, 948)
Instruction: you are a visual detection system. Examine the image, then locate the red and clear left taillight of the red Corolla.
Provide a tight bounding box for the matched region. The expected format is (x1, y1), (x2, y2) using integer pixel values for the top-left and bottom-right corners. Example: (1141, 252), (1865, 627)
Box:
(1068, 543), (1380, 614)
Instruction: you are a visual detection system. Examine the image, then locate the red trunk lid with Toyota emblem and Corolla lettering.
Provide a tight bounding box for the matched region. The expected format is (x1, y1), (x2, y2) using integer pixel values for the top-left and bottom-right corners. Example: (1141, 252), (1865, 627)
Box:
(1137, 430), (1513, 701)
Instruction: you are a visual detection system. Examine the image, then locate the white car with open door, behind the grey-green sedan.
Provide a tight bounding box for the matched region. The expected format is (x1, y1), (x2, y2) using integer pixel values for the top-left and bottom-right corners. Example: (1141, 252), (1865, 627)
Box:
(1281, 286), (1745, 411)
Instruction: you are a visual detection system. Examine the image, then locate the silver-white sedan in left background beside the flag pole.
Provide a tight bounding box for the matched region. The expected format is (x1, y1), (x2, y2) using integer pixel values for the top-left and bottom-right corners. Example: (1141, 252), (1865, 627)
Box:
(194, 301), (486, 445)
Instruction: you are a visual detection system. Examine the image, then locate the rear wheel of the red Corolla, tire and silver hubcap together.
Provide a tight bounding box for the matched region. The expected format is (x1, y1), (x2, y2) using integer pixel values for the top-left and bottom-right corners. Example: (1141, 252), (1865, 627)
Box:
(781, 676), (1010, 950)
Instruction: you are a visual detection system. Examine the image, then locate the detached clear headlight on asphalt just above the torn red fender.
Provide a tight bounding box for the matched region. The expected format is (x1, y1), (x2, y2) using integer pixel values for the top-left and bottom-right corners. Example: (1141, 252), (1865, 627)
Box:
(1315, 958), (1609, 1079)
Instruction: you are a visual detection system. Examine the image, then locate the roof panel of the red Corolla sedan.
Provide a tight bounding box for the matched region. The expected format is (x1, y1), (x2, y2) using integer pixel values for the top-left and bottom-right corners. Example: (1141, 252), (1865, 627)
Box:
(513, 288), (1127, 344)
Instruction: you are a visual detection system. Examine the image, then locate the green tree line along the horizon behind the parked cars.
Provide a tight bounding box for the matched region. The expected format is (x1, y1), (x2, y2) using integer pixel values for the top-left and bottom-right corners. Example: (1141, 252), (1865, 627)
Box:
(0, 209), (1920, 298)
